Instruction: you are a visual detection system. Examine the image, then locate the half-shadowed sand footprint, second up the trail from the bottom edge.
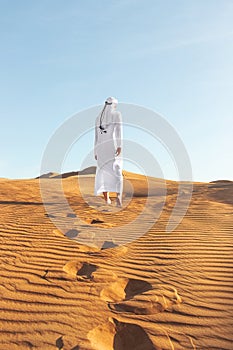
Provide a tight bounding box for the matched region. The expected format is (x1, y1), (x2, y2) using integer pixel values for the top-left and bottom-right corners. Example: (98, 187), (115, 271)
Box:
(100, 278), (152, 302)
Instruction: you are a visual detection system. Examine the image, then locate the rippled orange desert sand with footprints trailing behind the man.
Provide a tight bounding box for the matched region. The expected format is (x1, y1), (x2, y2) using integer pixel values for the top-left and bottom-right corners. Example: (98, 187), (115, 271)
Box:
(0, 172), (233, 350)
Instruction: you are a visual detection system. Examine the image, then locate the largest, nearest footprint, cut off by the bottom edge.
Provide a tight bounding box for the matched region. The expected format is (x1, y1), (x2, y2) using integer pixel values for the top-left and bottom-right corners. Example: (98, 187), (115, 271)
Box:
(87, 318), (157, 350)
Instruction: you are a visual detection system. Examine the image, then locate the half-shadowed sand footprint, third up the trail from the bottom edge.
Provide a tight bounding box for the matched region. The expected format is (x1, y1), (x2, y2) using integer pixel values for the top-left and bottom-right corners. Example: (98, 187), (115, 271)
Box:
(63, 260), (98, 280)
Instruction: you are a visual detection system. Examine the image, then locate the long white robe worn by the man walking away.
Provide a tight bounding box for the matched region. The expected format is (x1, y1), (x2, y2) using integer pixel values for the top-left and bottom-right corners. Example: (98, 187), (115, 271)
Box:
(94, 106), (123, 195)
